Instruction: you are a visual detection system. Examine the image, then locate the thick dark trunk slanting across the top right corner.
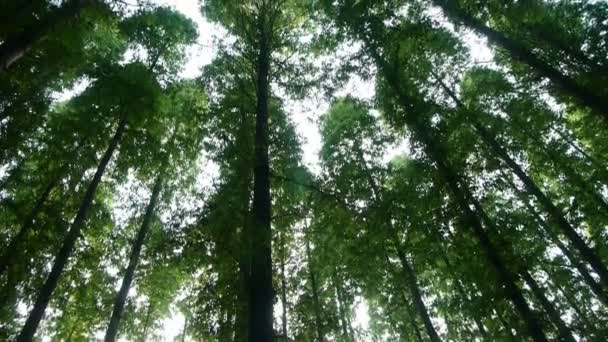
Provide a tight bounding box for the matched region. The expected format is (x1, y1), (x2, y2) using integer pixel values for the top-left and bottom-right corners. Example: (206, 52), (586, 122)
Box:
(433, 0), (608, 120)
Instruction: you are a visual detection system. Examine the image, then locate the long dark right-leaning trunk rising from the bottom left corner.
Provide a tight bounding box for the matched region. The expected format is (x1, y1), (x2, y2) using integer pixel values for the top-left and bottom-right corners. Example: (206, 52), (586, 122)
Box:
(17, 116), (127, 342)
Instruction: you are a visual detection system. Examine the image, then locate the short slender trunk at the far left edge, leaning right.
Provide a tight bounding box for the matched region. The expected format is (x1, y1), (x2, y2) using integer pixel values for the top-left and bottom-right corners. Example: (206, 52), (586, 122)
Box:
(0, 177), (61, 277)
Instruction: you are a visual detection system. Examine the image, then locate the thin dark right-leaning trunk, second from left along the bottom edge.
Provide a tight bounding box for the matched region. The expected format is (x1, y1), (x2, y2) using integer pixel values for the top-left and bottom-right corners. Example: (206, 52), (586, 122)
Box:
(104, 174), (164, 342)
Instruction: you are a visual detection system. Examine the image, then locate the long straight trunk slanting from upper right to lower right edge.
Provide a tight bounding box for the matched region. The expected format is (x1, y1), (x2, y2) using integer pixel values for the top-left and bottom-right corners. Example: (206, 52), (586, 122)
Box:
(435, 75), (608, 296)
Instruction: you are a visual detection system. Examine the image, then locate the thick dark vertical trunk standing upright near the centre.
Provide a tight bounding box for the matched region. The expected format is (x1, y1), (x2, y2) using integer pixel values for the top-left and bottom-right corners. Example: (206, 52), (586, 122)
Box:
(249, 9), (274, 342)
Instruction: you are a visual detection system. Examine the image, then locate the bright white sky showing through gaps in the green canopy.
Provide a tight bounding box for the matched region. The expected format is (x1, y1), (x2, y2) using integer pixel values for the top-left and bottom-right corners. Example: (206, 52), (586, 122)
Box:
(45, 0), (492, 341)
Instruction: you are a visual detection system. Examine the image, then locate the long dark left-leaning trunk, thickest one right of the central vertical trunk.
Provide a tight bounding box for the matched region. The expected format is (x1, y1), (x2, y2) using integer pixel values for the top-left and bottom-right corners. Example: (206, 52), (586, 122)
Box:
(369, 46), (547, 341)
